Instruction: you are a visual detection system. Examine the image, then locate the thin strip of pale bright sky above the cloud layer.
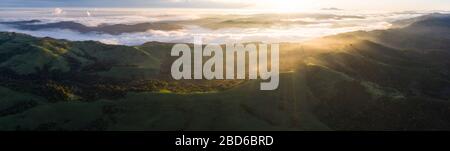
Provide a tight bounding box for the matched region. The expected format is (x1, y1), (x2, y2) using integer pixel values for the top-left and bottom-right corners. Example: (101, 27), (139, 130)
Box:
(0, 0), (450, 11)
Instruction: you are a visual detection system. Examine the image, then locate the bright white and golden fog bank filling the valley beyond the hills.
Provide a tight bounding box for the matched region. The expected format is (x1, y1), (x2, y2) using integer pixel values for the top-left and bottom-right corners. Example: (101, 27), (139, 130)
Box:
(0, 8), (442, 45)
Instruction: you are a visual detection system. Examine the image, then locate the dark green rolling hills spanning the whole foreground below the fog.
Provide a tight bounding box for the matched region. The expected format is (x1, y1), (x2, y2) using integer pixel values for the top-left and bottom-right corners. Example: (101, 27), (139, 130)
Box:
(0, 14), (450, 130)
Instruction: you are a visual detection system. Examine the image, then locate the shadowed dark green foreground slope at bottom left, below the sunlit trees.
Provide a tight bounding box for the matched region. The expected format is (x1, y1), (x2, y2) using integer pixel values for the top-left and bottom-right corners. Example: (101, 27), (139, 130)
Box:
(0, 73), (328, 130)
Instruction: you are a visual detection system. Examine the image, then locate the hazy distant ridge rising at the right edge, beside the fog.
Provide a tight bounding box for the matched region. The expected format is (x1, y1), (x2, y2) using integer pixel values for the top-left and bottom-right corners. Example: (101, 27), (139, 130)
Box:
(330, 14), (450, 51)
